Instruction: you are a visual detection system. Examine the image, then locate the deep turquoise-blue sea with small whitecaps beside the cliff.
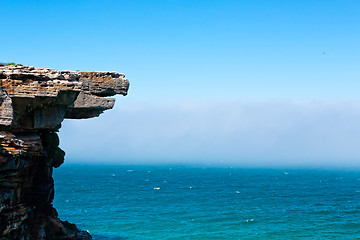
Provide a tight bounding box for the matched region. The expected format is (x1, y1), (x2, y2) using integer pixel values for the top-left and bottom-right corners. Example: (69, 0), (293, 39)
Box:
(54, 164), (360, 240)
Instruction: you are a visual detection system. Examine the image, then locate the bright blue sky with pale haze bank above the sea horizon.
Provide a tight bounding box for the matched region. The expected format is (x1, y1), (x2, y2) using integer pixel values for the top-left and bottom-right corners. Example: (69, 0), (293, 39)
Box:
(0, 0), (360, 167)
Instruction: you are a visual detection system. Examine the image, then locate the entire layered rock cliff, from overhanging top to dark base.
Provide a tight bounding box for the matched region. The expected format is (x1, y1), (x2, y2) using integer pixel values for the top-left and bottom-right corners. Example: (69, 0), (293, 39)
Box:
(0, 66), (129, 240)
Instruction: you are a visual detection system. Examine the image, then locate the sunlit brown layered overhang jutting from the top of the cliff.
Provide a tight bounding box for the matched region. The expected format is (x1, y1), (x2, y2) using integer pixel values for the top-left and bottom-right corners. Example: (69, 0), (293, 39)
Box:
(0, 65), (129, 131)
